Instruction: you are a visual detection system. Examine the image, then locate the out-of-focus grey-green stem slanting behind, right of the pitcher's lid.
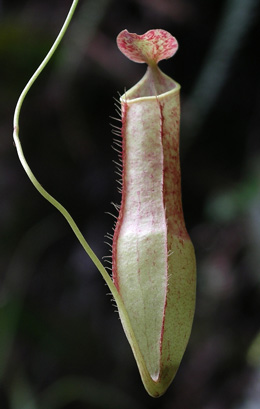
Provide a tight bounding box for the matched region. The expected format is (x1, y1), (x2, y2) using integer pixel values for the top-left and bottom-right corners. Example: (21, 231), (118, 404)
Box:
(183, 0), (258, 139)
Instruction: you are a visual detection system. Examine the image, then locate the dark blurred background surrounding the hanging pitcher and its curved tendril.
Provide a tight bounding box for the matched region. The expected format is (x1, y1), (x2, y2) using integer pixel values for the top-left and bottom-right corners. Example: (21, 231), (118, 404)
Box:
(0, 0), (260, 409)
